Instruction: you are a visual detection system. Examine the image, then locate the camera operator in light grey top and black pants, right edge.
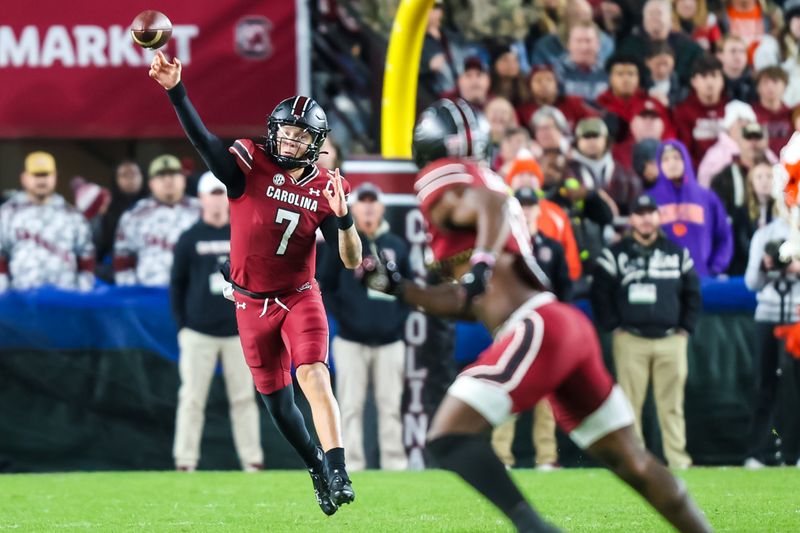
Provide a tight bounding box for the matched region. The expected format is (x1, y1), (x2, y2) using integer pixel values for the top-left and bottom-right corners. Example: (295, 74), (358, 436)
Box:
(744, 217), (800, 469)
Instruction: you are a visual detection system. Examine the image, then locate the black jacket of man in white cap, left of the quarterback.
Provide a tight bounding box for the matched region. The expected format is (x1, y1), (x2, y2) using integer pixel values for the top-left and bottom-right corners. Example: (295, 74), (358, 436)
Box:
(169, 220), (238, 337)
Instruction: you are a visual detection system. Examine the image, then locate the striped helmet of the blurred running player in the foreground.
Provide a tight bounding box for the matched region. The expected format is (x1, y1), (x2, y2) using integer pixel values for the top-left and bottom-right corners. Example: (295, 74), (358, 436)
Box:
(411, 98), (489, 168)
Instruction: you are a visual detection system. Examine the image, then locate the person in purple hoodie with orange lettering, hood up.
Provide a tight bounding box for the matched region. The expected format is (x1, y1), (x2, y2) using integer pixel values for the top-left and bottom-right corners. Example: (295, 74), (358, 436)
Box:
(650, 140), (733, 276)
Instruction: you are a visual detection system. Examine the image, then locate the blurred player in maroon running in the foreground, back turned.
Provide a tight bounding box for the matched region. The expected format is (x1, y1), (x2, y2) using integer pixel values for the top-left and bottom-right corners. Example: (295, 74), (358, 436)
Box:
(364, 100), (710, 532)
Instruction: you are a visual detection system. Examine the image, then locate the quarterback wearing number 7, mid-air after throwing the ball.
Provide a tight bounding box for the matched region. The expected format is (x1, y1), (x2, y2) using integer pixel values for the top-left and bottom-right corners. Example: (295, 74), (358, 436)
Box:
(149, 52), (361, 515)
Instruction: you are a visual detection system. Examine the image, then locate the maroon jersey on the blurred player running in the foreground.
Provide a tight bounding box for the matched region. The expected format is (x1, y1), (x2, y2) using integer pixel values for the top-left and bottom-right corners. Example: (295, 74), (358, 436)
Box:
(414, 158), (535, 272)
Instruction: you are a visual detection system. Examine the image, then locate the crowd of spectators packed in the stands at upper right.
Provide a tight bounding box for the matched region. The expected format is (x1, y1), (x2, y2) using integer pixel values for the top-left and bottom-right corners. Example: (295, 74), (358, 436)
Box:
(406, 0), (800, 290)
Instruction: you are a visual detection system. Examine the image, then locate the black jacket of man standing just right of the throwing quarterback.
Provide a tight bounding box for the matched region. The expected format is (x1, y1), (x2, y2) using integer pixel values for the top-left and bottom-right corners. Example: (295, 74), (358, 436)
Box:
(317, 221), (412, 346)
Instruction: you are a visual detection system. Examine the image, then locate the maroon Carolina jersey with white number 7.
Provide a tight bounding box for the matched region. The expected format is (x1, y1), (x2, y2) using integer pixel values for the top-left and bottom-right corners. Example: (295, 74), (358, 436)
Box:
(229, 139), (350, 294)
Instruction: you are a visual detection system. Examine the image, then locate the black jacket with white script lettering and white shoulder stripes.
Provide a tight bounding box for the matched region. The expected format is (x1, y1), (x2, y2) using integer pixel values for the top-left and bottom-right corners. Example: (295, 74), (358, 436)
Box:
(592, 235), (701, 338)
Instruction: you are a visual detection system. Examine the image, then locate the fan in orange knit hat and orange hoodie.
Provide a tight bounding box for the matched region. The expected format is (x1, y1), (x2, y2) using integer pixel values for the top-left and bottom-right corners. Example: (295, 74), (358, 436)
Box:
(506, 150), (581, 281)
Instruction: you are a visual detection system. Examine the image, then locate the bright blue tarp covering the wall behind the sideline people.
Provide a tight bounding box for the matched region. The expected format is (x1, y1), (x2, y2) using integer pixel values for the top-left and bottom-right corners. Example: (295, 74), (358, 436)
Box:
(0, 278), (755, 363)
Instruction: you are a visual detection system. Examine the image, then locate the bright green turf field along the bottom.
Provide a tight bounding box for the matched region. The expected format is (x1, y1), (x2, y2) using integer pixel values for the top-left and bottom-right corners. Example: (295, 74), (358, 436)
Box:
(0, 467), (800, 533)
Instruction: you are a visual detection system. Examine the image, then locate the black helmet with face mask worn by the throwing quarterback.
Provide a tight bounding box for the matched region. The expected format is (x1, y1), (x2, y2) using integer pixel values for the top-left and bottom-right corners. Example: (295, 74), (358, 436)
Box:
(267, 96), (331, 170)
